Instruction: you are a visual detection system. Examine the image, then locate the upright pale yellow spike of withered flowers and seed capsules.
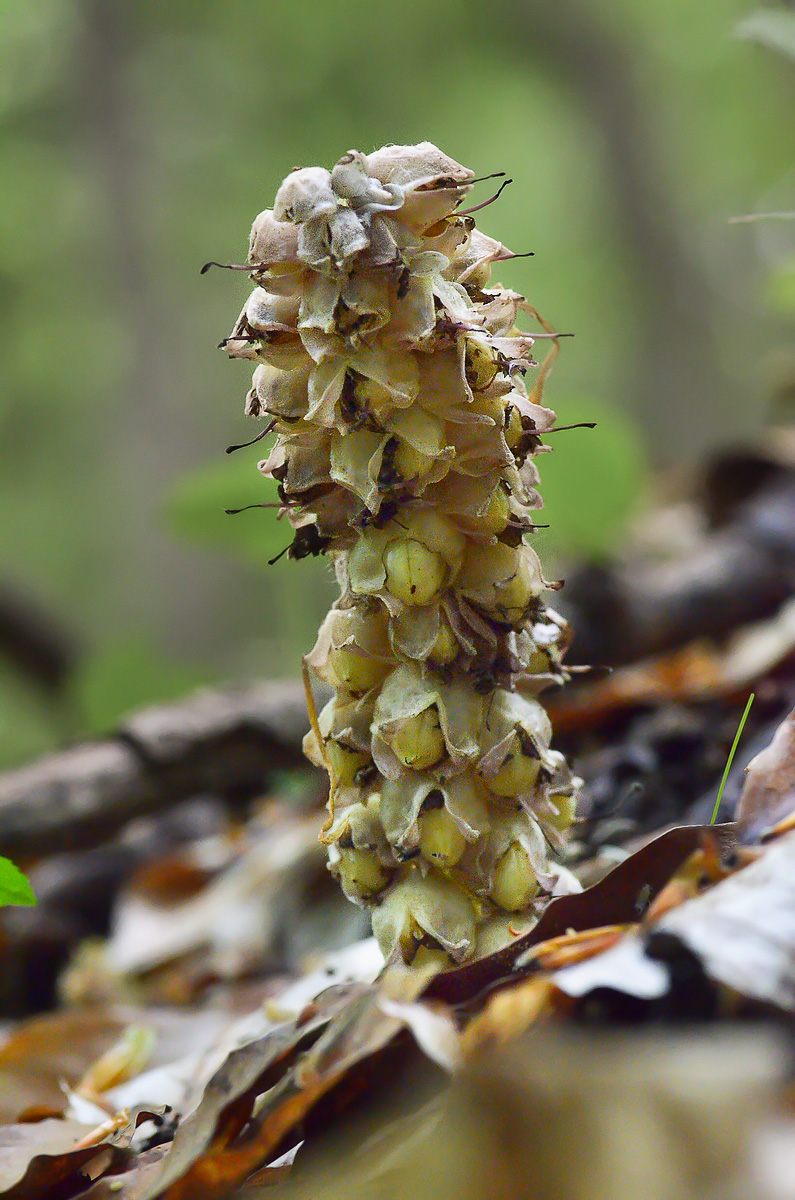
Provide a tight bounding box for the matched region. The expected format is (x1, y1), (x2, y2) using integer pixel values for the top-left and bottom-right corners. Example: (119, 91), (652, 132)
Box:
(225, 142), (578, 964)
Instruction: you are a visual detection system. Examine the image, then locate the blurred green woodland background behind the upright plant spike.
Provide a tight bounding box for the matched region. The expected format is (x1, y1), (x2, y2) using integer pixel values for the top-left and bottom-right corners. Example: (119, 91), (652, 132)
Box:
(0, 0), (795, 767)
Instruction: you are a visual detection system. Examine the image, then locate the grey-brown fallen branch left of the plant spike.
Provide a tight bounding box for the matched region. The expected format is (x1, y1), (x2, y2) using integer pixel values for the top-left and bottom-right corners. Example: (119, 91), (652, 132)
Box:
(0, 682), (326, 863)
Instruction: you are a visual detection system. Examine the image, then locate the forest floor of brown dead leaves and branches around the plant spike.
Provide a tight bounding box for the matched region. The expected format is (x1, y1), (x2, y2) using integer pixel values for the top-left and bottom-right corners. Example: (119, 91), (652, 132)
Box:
(0, 434), (795, 1200)
